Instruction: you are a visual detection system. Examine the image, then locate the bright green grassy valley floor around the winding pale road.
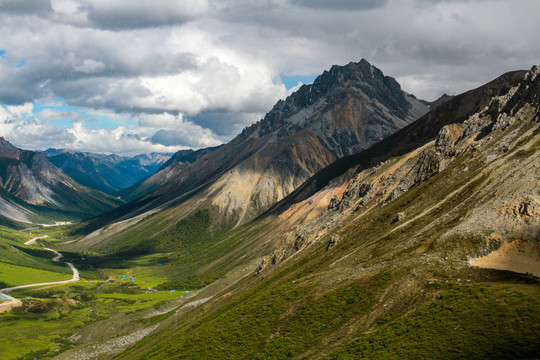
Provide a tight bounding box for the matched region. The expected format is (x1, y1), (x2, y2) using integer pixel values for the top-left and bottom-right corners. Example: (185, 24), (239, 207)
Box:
(0, 227), (194, 359)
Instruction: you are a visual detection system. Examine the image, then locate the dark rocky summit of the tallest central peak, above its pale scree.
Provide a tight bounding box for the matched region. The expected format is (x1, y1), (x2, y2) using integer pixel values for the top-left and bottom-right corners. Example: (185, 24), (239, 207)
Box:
(257, 60), (422, 157)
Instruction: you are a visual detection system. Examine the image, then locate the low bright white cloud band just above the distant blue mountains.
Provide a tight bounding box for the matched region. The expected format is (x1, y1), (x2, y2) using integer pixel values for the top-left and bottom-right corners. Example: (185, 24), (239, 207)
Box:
(0, 103), (211, 155)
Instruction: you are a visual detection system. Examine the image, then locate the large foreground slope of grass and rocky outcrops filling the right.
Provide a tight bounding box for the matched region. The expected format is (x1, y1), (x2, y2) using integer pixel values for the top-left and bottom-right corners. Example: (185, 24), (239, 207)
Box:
(56, 67), (540, 359)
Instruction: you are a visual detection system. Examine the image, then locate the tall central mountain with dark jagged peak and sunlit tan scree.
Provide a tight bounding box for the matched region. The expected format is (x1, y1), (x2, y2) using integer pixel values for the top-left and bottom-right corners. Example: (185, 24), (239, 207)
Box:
(95, 60), (429, 229)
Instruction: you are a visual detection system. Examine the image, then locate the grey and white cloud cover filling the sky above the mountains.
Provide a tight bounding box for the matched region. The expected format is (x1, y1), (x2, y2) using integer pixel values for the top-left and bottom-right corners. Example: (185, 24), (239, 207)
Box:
(0, 0), (540, 152)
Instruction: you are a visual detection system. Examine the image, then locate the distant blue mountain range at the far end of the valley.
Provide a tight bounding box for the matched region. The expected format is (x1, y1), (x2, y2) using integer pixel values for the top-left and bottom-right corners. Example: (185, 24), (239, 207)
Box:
(43, 149), (172, 195)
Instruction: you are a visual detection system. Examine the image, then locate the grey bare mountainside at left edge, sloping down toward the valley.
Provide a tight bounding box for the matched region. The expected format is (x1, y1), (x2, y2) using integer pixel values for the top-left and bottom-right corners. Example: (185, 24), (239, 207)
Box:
(0, 138), (122, 222)
